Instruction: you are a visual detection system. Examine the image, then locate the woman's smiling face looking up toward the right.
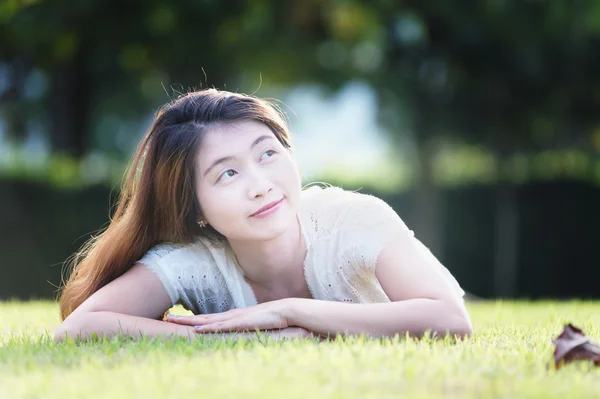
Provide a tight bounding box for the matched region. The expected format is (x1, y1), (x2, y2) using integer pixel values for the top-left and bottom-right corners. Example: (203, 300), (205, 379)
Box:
(195, 121), (301, 240)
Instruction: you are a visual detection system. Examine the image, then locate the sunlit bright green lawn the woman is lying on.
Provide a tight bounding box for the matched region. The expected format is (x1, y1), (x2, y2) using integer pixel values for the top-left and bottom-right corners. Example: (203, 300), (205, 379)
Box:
(0, 301), (600, 399)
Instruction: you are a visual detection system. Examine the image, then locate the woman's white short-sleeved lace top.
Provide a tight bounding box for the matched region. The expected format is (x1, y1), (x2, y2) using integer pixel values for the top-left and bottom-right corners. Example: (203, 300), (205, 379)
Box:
(139, 186), (464, 314)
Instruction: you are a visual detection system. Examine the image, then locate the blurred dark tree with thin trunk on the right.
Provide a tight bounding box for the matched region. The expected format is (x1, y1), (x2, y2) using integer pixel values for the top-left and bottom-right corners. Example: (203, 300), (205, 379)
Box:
(386, 0), (600, 296)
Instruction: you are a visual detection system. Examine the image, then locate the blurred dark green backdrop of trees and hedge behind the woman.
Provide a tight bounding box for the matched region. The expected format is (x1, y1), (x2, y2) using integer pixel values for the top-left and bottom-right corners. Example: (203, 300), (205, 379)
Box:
(0, 0), (600, 299)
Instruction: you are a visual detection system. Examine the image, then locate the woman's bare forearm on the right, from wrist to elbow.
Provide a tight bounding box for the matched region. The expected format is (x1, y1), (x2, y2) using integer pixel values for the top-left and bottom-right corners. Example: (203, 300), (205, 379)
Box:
(288, 298), (472, 337)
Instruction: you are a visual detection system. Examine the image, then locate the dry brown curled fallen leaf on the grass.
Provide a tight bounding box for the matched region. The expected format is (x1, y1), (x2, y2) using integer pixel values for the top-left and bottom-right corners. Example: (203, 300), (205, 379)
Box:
(552, 324), (600, 369)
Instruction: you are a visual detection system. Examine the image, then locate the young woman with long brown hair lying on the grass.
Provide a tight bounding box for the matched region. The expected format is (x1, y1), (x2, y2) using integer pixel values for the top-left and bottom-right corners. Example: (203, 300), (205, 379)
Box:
(55, 89), (472, 341)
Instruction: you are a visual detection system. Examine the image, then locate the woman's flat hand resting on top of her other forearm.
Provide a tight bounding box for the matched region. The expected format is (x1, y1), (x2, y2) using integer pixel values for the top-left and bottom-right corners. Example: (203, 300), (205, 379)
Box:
(167, 298), (293, 333)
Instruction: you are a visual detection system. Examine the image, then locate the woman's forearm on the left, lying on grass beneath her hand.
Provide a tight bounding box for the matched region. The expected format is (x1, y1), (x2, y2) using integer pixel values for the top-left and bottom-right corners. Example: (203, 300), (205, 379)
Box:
(54, 312), (306, 342)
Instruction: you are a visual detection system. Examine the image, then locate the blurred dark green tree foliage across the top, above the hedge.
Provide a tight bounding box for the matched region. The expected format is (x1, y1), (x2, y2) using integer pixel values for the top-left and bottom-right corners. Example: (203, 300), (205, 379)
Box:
(0, 0), (600, 162)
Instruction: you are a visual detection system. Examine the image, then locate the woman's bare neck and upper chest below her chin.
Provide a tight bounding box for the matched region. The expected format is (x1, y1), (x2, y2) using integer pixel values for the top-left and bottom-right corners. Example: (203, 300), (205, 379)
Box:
(229, 218), (306, 290)
